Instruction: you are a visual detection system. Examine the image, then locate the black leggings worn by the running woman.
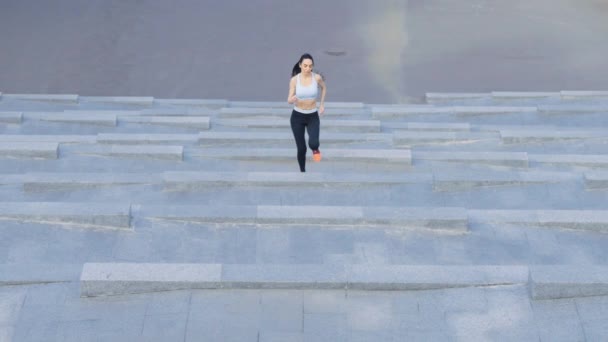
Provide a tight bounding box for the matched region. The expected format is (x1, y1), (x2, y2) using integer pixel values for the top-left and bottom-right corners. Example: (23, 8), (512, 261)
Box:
(290, 110), (321, 172)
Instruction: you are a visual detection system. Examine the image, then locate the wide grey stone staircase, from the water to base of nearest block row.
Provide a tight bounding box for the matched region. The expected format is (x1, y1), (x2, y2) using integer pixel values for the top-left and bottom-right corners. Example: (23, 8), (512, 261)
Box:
(0, 92), (608, 300)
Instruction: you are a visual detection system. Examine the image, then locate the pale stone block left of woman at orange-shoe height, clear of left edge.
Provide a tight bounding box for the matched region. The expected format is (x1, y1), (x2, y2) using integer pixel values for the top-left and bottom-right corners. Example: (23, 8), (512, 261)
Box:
(66, 145), (184, 161)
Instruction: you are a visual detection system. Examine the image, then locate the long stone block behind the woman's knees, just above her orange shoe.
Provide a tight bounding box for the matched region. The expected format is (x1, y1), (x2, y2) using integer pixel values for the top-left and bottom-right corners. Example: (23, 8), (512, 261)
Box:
(198, 131), (393, 146)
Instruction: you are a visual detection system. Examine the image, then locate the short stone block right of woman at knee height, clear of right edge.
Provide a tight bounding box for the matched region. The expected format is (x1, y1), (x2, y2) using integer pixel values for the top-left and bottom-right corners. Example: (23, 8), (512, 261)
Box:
(393, 131), (500, 146)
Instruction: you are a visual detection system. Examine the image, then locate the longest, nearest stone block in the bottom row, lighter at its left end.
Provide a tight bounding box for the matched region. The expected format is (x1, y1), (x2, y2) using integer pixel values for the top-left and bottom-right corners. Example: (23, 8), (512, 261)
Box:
(80, 263), (529, 297)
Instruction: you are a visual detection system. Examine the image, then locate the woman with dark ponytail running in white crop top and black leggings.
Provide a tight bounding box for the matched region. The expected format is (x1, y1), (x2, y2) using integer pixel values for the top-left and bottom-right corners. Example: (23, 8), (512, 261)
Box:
(287, 53), (327, 172)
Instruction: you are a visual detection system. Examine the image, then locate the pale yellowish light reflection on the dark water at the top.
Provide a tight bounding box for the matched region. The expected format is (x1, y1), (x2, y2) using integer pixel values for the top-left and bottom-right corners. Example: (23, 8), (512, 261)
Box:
(358, 0), (408, 102)
